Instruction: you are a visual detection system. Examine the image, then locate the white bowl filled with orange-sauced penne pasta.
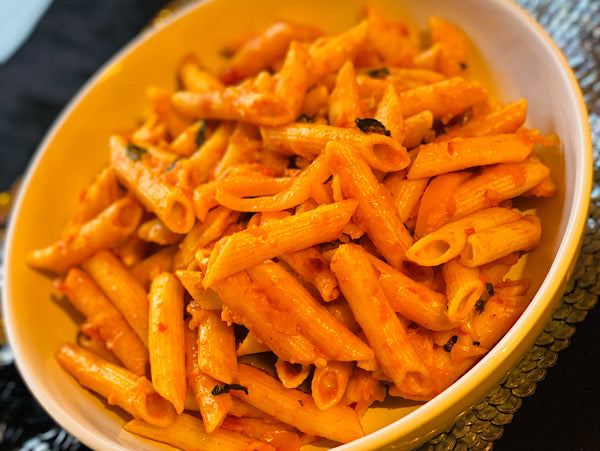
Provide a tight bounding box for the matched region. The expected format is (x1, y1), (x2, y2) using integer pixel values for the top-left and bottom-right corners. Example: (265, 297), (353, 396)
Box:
(3, 0), (591, 449)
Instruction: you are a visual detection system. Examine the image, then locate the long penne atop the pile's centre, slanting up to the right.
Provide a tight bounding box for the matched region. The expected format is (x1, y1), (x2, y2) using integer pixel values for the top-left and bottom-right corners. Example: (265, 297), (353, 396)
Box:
(203, 200), (356, 288)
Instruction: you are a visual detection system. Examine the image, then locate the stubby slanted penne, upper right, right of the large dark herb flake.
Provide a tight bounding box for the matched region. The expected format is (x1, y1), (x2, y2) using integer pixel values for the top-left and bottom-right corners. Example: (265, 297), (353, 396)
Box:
(398, 77), (487, 122)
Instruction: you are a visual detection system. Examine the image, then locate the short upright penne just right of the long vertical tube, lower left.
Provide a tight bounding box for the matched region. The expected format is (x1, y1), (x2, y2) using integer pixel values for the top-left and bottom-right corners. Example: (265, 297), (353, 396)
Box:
(194, 310), (237, 384)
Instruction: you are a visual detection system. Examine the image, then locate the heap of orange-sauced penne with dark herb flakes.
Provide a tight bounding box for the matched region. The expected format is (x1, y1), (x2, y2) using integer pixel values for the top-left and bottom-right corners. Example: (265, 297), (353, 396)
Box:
(28, 5), (557, 450)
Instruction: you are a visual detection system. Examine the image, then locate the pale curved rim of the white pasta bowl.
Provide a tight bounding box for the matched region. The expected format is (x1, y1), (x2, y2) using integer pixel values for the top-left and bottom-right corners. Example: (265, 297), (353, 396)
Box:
(1, 0), (593, 450)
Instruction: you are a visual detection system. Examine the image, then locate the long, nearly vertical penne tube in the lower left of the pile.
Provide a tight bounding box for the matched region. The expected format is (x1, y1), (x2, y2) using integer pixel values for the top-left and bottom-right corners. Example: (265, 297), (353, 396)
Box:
(148, 272), (187, 414)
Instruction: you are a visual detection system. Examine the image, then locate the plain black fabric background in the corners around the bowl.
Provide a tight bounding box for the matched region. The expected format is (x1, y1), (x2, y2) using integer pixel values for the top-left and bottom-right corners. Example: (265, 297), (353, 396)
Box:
(0, 0), (600, 451)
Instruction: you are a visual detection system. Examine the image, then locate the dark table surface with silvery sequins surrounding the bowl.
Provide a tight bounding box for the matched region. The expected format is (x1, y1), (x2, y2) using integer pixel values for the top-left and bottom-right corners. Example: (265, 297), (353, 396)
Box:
(0, 0), (600, 451)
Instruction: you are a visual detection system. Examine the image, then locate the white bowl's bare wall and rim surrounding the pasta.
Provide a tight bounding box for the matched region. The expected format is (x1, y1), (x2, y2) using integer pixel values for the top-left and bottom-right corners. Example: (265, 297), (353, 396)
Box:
(3, 0), (591, 450)
